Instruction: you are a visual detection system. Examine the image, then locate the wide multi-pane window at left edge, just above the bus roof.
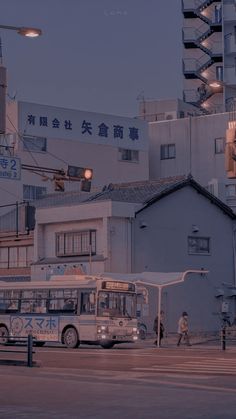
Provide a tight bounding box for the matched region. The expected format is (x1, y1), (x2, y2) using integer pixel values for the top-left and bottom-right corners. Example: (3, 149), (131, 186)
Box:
(0, 246), (33, 269)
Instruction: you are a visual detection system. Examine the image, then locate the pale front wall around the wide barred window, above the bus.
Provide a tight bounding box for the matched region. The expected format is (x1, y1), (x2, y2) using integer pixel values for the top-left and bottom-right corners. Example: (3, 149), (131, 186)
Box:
(31, 201), (137, 280)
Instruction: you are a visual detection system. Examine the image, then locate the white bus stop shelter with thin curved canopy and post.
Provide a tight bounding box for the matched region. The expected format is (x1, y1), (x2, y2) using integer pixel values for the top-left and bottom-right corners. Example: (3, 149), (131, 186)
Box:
(101, 269), (208, 347)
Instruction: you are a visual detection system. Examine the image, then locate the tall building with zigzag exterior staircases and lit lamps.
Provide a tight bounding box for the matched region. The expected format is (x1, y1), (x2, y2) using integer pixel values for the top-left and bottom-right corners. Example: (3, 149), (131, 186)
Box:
(182, 0), (236, 114)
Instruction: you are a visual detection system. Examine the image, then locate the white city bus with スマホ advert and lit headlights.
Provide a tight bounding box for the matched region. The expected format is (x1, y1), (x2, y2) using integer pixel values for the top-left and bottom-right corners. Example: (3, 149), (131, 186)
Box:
(0, 275), (138, 348)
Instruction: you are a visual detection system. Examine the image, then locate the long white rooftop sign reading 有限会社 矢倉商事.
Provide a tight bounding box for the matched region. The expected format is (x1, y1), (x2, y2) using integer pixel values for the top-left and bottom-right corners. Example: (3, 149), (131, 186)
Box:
(19, 102), (148, 150)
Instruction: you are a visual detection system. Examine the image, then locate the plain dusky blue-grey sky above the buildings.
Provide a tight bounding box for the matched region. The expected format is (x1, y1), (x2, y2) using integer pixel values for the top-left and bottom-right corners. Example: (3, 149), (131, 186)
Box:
(0, 0), (182, 116)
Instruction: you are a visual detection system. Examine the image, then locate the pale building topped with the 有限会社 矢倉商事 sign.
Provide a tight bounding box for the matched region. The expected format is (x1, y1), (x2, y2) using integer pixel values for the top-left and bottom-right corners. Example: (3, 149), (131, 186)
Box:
(0, 102), (149, 208)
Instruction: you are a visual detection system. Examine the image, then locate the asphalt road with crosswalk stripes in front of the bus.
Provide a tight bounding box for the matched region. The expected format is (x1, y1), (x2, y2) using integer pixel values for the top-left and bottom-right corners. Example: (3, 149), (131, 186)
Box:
(0, 342), (236, 419)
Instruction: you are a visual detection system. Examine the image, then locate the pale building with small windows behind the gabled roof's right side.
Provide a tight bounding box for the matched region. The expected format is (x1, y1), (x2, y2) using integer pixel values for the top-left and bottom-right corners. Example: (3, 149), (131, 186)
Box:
(149, 112), (236, 210)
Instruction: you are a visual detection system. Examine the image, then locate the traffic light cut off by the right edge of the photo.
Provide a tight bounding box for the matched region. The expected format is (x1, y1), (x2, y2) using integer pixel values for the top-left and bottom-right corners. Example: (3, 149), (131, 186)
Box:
(225, 127), (236, 179)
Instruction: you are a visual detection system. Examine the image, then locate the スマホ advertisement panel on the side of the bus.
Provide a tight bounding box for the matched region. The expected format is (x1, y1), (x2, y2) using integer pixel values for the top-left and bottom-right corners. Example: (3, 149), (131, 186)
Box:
(10, 316), (59, 342)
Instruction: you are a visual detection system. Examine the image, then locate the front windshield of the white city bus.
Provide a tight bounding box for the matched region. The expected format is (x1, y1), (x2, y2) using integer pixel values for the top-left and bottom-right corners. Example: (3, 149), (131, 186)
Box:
(98, 291), (136, 319)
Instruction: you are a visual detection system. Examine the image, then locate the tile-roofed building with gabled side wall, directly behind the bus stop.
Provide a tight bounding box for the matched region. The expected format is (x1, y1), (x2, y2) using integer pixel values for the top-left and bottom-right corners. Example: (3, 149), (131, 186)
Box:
(31, 177), (236, 332)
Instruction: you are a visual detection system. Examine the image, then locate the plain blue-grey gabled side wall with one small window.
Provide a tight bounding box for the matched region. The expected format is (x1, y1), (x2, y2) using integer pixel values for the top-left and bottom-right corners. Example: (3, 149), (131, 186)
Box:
(133, 187), (235, 332)
